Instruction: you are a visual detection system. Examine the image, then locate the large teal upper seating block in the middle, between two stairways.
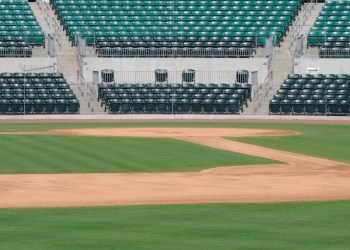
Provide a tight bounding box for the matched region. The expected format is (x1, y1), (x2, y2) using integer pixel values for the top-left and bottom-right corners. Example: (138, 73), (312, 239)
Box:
(52, 0), (301, 57)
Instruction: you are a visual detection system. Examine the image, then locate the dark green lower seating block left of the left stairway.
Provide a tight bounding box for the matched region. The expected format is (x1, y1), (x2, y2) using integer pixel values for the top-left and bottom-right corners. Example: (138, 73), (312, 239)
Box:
(0, 73), (80, 115)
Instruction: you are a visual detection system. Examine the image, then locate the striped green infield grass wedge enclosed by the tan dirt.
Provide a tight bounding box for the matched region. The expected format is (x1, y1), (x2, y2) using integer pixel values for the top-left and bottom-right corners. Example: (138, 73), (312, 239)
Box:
(0, 135), (277, 174)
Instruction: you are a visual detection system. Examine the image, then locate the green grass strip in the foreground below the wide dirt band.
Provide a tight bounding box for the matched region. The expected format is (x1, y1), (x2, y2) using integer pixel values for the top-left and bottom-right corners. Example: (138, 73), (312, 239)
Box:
(0, 201), (350, 250)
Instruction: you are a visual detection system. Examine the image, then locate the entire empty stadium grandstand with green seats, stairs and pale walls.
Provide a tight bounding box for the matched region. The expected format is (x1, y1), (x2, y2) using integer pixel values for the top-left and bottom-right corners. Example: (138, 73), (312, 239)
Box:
(0, 0), (350, 116)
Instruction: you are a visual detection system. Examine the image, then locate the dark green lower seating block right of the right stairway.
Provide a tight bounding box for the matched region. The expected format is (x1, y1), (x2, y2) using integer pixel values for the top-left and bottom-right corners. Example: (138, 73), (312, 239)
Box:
(269, 74), (350, 115)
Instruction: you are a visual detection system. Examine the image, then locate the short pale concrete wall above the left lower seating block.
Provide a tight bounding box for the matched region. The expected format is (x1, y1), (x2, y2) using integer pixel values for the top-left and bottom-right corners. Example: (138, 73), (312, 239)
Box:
(0, 58), (57, 72)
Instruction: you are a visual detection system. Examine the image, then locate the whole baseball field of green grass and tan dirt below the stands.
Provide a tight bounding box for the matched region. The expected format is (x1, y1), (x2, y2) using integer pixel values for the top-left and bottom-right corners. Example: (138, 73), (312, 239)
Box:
(0, 122), (350, 249)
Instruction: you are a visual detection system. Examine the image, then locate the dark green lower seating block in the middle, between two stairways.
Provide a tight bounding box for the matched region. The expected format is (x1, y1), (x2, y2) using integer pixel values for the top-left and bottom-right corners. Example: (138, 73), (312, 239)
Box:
(98, 83), (251, 114)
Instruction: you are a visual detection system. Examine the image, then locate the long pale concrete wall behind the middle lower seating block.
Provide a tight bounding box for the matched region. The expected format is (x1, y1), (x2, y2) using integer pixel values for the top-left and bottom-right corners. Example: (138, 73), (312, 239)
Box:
(82, 57), (267, 83)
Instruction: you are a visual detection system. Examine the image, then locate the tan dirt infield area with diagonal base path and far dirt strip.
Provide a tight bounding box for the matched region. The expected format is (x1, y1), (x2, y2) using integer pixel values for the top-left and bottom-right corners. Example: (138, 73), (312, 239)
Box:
(0, 128), (350, 207)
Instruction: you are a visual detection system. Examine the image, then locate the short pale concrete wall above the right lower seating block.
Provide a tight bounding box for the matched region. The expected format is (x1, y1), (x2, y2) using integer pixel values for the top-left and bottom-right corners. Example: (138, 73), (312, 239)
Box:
(294, 58), (350, 74)
